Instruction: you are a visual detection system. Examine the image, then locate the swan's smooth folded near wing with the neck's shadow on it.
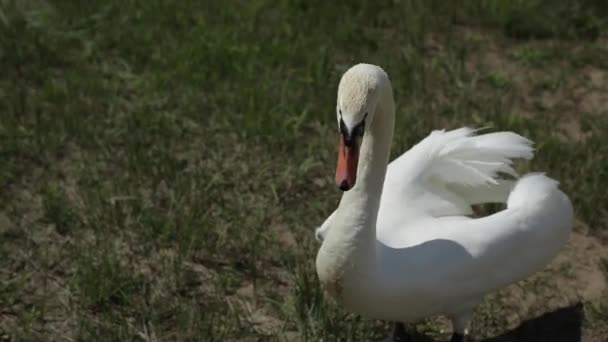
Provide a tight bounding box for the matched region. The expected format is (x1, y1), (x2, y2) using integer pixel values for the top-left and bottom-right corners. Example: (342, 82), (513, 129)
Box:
(378, 174), (574, 296)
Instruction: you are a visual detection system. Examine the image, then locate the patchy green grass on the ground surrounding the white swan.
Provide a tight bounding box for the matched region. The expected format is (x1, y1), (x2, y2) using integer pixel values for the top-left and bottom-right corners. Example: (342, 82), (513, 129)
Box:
(0, 0), (608, 341)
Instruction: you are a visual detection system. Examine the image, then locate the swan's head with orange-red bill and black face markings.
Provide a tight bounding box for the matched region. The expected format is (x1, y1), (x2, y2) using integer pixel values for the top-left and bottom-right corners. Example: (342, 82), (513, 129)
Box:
(336, 64), (388, 191)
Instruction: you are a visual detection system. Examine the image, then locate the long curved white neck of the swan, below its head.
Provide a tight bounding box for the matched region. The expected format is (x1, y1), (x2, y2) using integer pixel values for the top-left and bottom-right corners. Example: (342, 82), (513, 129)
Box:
(317, 84), (394, 296)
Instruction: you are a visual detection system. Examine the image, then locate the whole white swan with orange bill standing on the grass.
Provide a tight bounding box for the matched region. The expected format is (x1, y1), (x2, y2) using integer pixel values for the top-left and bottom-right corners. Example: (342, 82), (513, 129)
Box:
(315, 63), (573, 342)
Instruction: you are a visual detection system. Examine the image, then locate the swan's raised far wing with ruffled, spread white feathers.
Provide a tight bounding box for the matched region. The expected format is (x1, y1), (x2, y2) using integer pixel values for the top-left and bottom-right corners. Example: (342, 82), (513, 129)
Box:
(381, 128), (533, 216)
